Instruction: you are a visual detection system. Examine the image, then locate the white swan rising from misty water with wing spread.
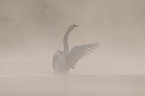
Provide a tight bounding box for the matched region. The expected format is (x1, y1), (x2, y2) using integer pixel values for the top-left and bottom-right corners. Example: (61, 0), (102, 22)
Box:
(52, 24), (99, 74)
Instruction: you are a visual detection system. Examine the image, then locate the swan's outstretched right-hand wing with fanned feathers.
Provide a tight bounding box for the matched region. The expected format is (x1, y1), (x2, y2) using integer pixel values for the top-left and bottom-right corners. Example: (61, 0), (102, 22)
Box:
(66, 42), (99, 69)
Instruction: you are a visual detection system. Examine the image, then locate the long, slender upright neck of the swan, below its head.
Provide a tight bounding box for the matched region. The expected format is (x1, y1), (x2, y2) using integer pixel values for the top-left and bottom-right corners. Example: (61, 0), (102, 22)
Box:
(63, 29), (72, 54)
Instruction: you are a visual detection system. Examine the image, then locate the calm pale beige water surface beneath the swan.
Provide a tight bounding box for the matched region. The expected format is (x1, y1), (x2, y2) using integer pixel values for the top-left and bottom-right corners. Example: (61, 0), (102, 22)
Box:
(0, 73), (145, 96)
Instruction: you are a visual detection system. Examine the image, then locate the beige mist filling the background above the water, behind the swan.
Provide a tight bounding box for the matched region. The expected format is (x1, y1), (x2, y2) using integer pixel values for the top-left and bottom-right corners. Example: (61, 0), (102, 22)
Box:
(0, 0), (145, 74)
